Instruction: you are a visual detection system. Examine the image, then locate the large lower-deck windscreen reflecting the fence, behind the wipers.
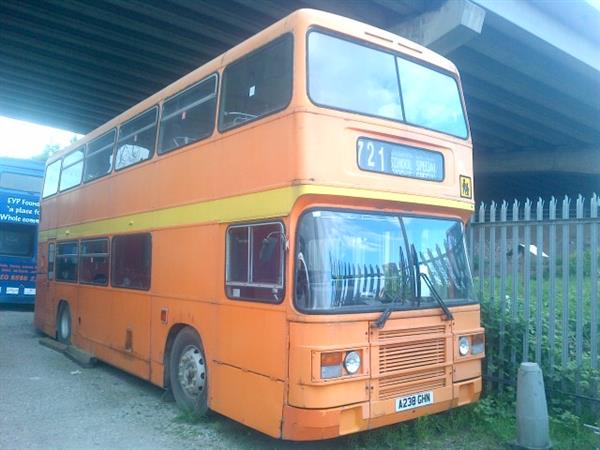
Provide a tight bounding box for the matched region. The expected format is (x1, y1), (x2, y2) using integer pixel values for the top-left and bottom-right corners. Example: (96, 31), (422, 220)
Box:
(295, 210), (475, 313)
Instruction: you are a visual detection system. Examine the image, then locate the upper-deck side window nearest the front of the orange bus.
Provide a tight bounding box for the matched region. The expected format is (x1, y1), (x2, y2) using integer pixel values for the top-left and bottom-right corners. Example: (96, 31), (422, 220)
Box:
(219, 34), (292, 131)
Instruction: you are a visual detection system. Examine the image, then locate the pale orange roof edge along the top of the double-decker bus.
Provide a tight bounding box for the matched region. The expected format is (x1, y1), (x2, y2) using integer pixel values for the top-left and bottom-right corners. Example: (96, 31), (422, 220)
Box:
(46, 8), (458, 164)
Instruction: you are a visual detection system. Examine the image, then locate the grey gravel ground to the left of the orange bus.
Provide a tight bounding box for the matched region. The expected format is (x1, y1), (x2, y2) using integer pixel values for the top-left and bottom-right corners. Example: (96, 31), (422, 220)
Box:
(0, 309), (344, 450)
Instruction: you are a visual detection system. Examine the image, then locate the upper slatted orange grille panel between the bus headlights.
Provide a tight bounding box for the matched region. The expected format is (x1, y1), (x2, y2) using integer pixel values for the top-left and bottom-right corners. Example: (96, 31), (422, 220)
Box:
(379, 337), (446, 375)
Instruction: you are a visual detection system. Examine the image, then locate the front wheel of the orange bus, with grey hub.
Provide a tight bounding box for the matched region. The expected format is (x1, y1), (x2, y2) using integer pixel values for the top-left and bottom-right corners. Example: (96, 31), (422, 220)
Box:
(169, 327), (208, 416)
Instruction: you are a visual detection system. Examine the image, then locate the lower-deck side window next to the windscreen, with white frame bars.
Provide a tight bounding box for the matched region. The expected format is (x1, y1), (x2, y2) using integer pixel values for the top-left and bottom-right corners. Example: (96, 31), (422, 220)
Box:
(226, 222), (285, 302)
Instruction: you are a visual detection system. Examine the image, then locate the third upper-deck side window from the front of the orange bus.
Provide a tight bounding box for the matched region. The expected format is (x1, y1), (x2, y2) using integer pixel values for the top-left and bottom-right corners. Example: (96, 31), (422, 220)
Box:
(115, 106), (158, 170)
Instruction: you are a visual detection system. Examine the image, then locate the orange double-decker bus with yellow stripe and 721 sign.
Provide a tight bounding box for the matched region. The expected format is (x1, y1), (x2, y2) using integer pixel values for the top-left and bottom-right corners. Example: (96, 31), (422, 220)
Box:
(35, 10), (484, 440)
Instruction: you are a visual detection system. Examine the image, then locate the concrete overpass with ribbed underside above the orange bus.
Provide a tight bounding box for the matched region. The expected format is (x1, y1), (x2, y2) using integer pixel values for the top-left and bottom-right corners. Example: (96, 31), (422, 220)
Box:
(0, 0), (600, 200)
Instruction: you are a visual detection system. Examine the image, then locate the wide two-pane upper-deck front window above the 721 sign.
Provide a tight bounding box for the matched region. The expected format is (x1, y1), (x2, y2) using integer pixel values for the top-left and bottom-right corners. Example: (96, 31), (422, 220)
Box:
(308, 31), (468, 139)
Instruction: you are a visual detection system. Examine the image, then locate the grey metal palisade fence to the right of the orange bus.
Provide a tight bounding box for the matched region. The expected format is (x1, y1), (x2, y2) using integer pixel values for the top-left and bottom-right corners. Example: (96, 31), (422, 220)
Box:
(467, 194), (600, 412)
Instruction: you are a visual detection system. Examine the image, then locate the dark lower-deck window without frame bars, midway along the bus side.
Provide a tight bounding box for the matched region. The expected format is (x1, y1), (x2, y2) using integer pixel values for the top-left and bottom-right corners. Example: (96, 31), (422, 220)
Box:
(111, 233), (152, 290)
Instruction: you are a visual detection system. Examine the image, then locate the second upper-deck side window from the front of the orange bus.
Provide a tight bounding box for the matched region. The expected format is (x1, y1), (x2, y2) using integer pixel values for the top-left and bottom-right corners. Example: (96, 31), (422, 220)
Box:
(158, 75), (217, 153)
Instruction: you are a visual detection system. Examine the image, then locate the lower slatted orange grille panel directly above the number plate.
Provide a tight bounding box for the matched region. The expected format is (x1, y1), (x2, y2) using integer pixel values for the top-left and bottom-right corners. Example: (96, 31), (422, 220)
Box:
(378, 368), (446, 400)
